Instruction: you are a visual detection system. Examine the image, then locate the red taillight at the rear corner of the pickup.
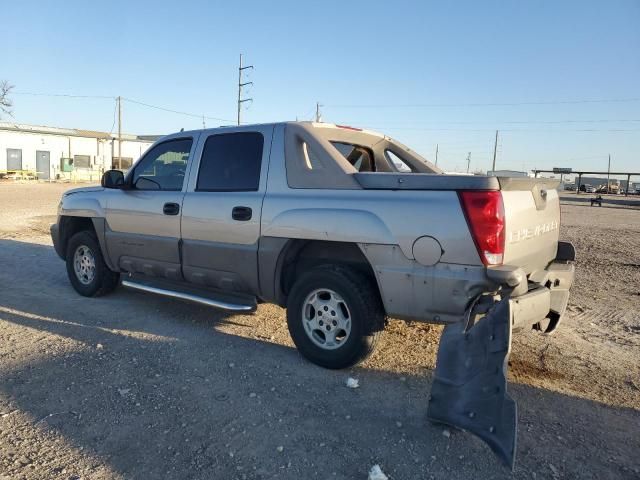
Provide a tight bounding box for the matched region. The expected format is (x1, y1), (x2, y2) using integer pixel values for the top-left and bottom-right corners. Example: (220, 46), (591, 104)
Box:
(460, 190), (505, 265)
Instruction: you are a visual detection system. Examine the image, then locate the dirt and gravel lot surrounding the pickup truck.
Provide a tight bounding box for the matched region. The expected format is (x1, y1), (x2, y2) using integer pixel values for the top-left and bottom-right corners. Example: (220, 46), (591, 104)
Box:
(0, 183), (640, 480)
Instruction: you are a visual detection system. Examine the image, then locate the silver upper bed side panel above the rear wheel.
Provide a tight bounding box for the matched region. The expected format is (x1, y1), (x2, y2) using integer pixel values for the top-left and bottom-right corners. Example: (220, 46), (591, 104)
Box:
(262, 189), (481, 265)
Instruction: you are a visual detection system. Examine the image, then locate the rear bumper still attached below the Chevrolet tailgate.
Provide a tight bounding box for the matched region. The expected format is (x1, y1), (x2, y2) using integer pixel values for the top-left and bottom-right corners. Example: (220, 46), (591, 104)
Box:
(487, 242), (576, 333)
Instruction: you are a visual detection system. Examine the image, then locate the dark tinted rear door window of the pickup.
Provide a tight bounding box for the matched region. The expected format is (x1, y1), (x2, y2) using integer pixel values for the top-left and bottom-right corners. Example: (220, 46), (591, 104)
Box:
(196, 132), (264, 192)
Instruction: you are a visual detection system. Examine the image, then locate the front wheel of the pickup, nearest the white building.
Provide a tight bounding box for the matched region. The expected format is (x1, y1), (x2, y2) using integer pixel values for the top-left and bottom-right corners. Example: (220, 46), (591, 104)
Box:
(66, 230), (120, 297)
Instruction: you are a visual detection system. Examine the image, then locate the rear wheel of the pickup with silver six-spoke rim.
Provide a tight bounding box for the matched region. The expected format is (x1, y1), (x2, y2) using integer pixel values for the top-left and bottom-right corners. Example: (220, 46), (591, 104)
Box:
(287, 265), (385, 369)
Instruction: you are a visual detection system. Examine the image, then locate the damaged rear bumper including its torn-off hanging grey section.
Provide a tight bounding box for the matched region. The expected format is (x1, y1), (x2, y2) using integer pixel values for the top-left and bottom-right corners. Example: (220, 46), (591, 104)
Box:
(427, 242), (575, 468)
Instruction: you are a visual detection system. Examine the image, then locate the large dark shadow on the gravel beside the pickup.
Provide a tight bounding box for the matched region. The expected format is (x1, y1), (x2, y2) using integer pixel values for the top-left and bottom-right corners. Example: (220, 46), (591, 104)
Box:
(0, 240), (640, 479)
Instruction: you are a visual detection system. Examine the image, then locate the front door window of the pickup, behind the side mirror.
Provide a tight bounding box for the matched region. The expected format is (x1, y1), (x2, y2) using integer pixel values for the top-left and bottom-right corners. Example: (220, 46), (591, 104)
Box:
(133, 138), (193, 191)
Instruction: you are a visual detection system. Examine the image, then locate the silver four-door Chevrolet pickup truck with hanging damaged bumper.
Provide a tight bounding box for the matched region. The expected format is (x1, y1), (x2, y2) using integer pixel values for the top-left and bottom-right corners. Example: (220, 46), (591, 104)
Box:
(51, 122), (575, 464)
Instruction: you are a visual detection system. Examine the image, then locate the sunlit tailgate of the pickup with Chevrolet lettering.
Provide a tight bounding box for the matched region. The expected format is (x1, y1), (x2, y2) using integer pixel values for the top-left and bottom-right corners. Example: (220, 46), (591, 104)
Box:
(498, 177), (560, 274)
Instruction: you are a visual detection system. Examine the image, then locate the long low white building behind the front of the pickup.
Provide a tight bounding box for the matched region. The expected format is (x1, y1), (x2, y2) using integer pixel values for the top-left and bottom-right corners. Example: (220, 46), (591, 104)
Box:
(0, 122), (157, 180)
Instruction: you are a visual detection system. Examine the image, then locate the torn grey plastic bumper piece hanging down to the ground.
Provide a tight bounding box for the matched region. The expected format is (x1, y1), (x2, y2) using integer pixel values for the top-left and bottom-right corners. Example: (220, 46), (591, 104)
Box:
(427, 298), (517, 469)
